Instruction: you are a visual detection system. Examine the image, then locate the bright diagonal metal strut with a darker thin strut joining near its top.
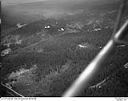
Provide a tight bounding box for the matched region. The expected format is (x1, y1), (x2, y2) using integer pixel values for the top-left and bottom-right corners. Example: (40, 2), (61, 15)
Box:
(62, 0), (128, 97)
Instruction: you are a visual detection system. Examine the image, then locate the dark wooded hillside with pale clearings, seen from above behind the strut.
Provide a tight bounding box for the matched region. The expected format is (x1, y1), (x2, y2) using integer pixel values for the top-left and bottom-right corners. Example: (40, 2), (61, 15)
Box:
(1, 1), (128, 96)
